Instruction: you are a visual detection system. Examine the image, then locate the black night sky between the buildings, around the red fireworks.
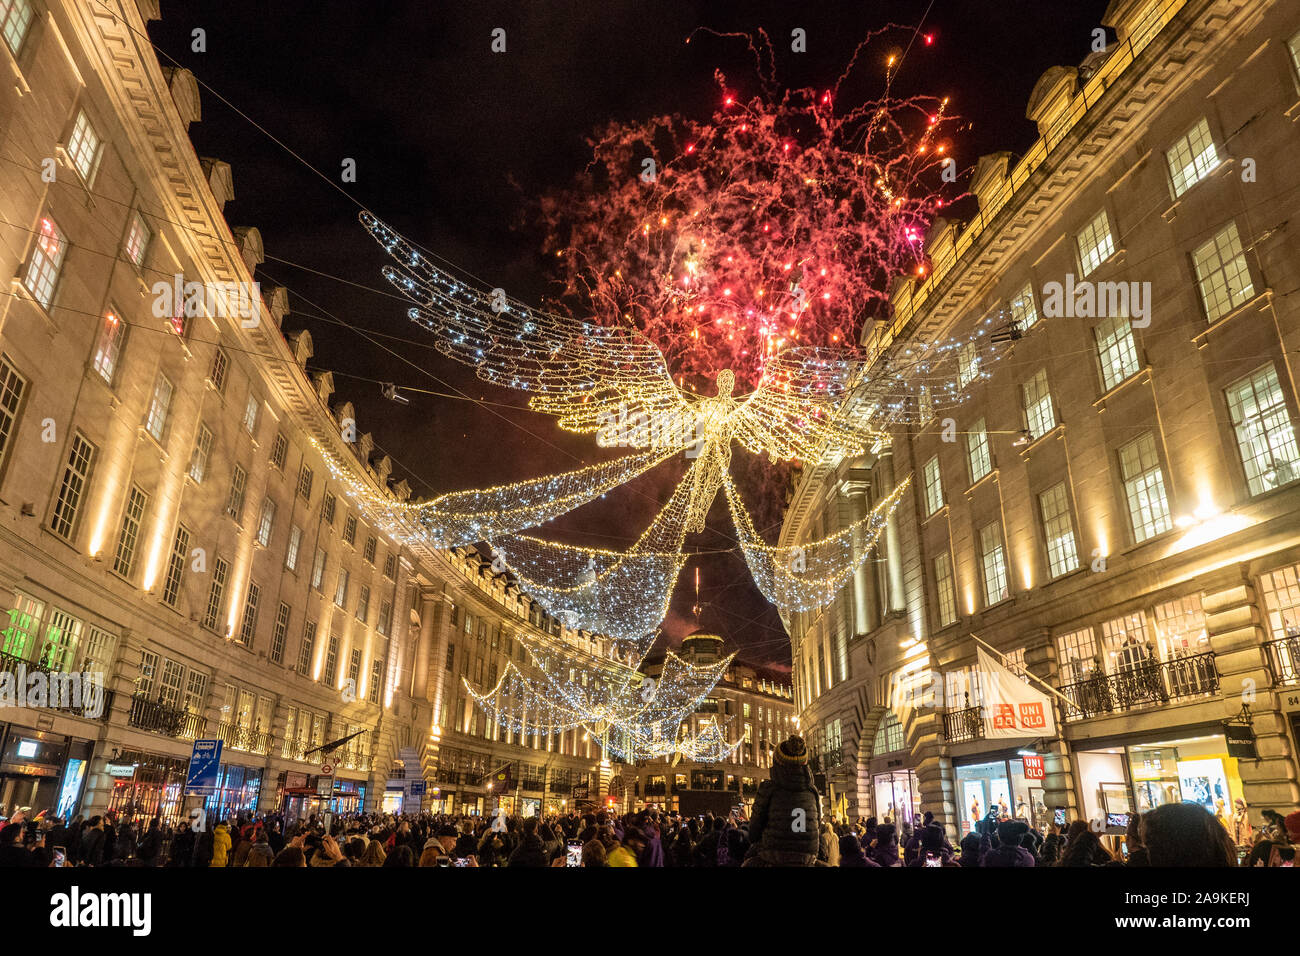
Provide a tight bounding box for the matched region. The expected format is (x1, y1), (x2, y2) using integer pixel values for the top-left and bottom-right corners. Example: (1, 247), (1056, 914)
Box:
(151, 0), (1106, 671)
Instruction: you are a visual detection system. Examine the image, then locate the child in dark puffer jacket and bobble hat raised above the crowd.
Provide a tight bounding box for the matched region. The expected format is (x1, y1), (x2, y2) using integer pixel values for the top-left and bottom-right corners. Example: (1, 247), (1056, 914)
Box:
(744, 735), (820, 866)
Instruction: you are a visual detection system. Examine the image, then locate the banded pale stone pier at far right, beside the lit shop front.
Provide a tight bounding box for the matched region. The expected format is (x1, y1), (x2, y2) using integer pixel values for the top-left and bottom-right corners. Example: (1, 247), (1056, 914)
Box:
(1203, 564), (1300, 826)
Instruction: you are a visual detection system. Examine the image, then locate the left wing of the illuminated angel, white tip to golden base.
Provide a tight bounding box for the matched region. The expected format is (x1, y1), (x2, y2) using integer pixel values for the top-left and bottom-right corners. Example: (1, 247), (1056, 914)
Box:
(360, 212), (690, 447)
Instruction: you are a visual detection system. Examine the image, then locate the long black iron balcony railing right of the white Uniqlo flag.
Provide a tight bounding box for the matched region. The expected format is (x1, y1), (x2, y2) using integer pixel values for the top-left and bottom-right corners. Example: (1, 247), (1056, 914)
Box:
(1061, 653), (1219, 721)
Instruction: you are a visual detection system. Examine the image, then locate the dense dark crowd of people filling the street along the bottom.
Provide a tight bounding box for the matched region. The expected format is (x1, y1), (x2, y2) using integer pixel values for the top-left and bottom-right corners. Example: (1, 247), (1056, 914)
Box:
(0, 737), (1300, 868)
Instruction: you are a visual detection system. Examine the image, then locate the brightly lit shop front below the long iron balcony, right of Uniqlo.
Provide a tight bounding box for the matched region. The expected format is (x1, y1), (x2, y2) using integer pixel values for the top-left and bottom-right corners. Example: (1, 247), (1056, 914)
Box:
(1074, 728), (1249, 844)
